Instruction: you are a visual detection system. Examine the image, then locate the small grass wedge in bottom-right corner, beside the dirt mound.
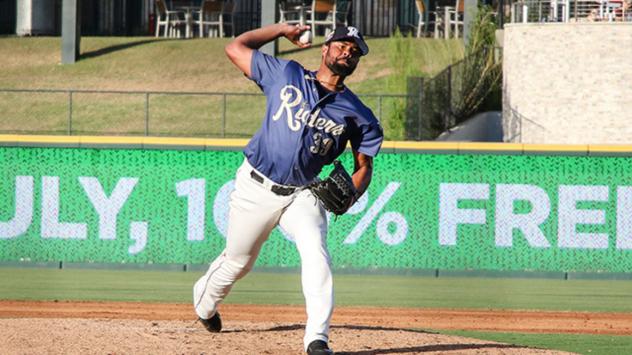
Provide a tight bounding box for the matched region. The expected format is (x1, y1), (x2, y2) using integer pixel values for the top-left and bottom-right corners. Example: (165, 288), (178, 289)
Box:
(440, 331), (632, 355)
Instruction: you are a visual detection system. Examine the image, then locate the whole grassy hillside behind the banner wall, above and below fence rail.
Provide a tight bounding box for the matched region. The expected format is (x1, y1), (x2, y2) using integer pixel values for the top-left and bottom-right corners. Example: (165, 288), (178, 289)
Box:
(0, 37), (464, 137)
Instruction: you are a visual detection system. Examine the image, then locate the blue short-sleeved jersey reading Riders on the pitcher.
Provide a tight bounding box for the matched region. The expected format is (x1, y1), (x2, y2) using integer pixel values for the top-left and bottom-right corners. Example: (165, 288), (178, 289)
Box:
(244, 51), (383, 186)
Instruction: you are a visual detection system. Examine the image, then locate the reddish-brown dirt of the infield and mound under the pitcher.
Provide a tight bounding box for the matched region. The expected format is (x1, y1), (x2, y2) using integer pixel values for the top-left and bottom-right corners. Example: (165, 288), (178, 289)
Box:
(0, 301), (632, 355)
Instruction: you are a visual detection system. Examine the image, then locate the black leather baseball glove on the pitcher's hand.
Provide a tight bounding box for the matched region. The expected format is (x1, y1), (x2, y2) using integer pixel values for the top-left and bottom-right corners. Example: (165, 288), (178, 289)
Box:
(308, 160), (358, 216)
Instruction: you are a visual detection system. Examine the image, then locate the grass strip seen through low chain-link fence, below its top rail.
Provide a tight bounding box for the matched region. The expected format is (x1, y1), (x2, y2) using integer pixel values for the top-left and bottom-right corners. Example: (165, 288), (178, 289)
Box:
(0, 89), (407, 138)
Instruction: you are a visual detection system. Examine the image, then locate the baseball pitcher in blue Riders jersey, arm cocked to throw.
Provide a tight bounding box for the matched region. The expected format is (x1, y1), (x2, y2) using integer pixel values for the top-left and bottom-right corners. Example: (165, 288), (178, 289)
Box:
(193, 23), (383, 354)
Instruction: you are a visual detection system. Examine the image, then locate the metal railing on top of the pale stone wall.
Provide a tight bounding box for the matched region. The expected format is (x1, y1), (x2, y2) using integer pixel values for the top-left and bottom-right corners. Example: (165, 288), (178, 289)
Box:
(511, 0), (632, 23)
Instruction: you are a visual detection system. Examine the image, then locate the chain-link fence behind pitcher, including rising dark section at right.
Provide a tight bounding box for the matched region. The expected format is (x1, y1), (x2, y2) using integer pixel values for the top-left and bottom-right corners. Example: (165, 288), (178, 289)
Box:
(0, 48), (502, 140)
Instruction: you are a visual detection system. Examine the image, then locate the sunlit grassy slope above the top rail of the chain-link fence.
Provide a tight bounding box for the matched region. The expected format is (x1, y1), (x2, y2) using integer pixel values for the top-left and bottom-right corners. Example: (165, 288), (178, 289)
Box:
(0, 37), (463, 94)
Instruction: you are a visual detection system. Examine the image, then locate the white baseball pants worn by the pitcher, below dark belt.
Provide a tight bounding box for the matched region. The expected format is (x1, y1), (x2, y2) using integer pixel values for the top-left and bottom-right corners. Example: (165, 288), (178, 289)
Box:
(193, 159), (333, 348)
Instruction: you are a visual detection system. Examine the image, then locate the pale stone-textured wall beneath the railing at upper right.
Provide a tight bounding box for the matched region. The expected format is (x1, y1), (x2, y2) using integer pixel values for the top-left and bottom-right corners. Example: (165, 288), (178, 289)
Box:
(503, 22), (632, 144)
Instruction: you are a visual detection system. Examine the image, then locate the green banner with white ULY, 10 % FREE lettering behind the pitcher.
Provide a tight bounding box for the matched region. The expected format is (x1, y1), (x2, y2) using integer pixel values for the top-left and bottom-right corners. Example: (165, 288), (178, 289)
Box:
(0, 147), (632, 272)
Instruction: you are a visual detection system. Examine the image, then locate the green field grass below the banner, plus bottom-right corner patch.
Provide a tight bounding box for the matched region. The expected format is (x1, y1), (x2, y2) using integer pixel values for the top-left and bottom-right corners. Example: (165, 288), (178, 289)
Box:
(0, 268), (632, 355)
